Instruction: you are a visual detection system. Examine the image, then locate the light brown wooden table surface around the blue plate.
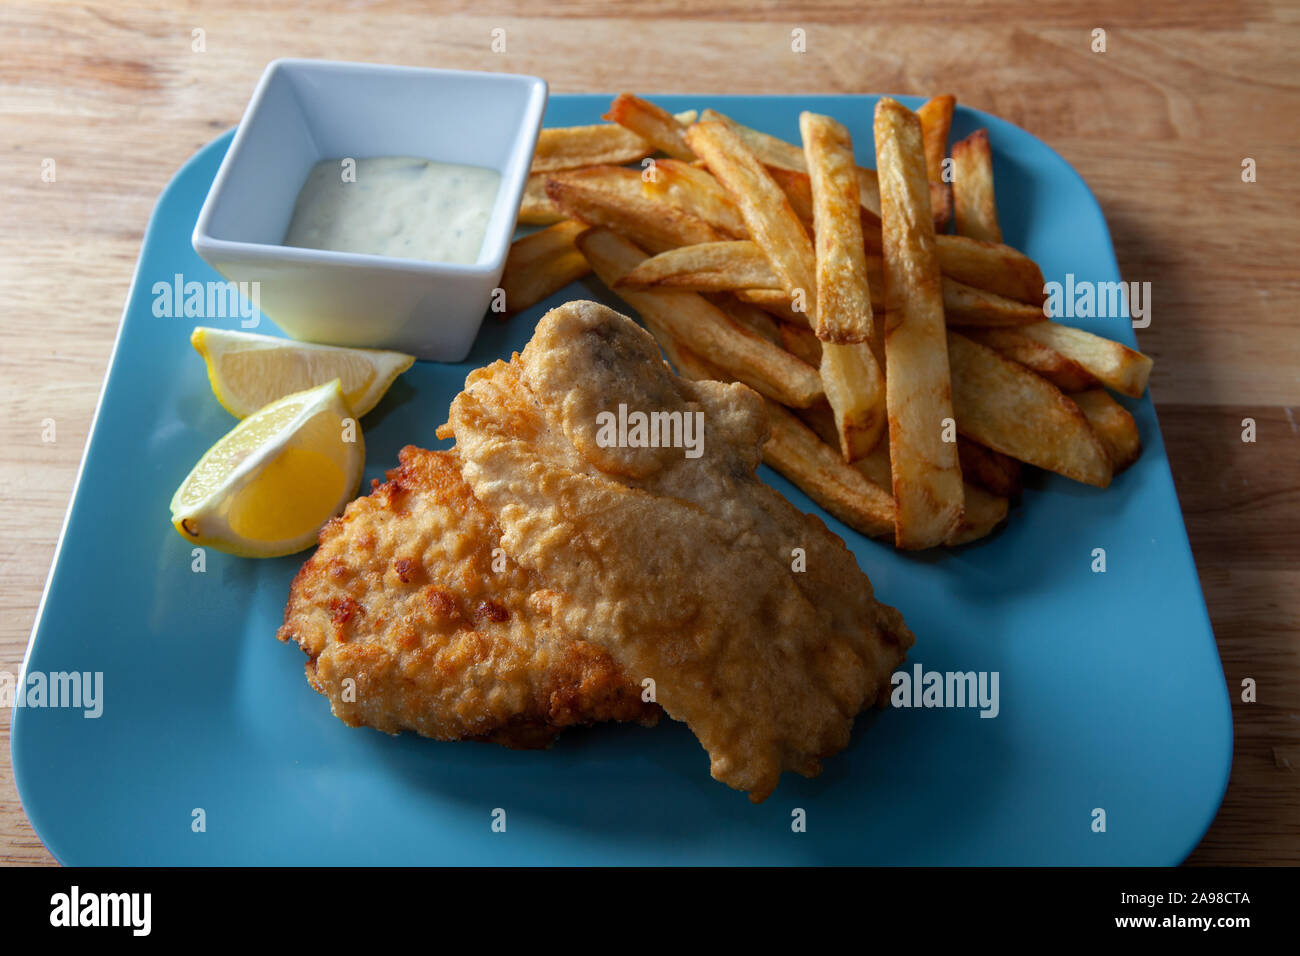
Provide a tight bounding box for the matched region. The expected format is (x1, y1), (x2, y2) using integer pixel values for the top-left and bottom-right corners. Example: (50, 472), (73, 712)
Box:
(0, 0), (1300, 864)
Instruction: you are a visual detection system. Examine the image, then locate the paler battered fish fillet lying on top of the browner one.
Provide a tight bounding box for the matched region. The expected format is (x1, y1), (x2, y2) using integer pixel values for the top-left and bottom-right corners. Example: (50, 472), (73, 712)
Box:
(439, 302), (913, 803)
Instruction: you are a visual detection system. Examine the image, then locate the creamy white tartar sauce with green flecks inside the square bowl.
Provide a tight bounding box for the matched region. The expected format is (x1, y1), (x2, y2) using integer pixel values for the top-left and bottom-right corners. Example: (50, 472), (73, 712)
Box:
(285, 156), (501, 264)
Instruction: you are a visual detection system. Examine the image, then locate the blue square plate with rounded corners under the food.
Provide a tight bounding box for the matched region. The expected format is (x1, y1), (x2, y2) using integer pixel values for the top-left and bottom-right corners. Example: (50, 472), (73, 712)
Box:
(13, 96), (1232, 865)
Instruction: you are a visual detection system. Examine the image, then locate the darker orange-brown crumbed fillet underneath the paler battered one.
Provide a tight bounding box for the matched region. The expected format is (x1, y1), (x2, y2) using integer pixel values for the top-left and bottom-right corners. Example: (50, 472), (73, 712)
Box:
(277, 446), (659, 748)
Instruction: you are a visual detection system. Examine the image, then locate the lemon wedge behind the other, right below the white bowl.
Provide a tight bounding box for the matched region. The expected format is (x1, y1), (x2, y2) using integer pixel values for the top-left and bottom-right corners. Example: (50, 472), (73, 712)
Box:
(190, 325), (415, 419)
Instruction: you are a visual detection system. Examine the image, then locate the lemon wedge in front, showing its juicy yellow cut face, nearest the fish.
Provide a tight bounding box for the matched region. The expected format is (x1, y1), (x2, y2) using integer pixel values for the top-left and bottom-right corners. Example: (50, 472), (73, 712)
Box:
(172, 378), (365, 558)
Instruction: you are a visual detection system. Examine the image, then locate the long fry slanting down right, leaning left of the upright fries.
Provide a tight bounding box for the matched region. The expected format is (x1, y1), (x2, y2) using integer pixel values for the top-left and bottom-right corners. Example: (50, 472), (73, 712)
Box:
(686, 122), (816, 325)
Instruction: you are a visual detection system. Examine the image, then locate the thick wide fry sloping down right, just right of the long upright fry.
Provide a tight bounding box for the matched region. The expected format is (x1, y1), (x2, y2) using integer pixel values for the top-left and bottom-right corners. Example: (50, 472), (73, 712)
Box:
(948, 332), (1114, 488)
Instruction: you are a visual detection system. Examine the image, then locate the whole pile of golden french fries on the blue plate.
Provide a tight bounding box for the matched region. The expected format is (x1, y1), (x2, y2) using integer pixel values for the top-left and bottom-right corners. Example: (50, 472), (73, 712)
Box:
(503, 94), (1152, 549)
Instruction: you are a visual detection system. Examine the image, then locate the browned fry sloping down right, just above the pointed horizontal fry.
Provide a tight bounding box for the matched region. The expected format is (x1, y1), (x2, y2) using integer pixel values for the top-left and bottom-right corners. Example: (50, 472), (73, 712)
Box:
(546, 165), (723, 252)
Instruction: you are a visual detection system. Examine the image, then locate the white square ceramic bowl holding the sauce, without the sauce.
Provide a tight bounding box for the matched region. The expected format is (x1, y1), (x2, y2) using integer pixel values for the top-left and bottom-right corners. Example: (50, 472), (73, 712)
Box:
(192, 60), (546, 362)
